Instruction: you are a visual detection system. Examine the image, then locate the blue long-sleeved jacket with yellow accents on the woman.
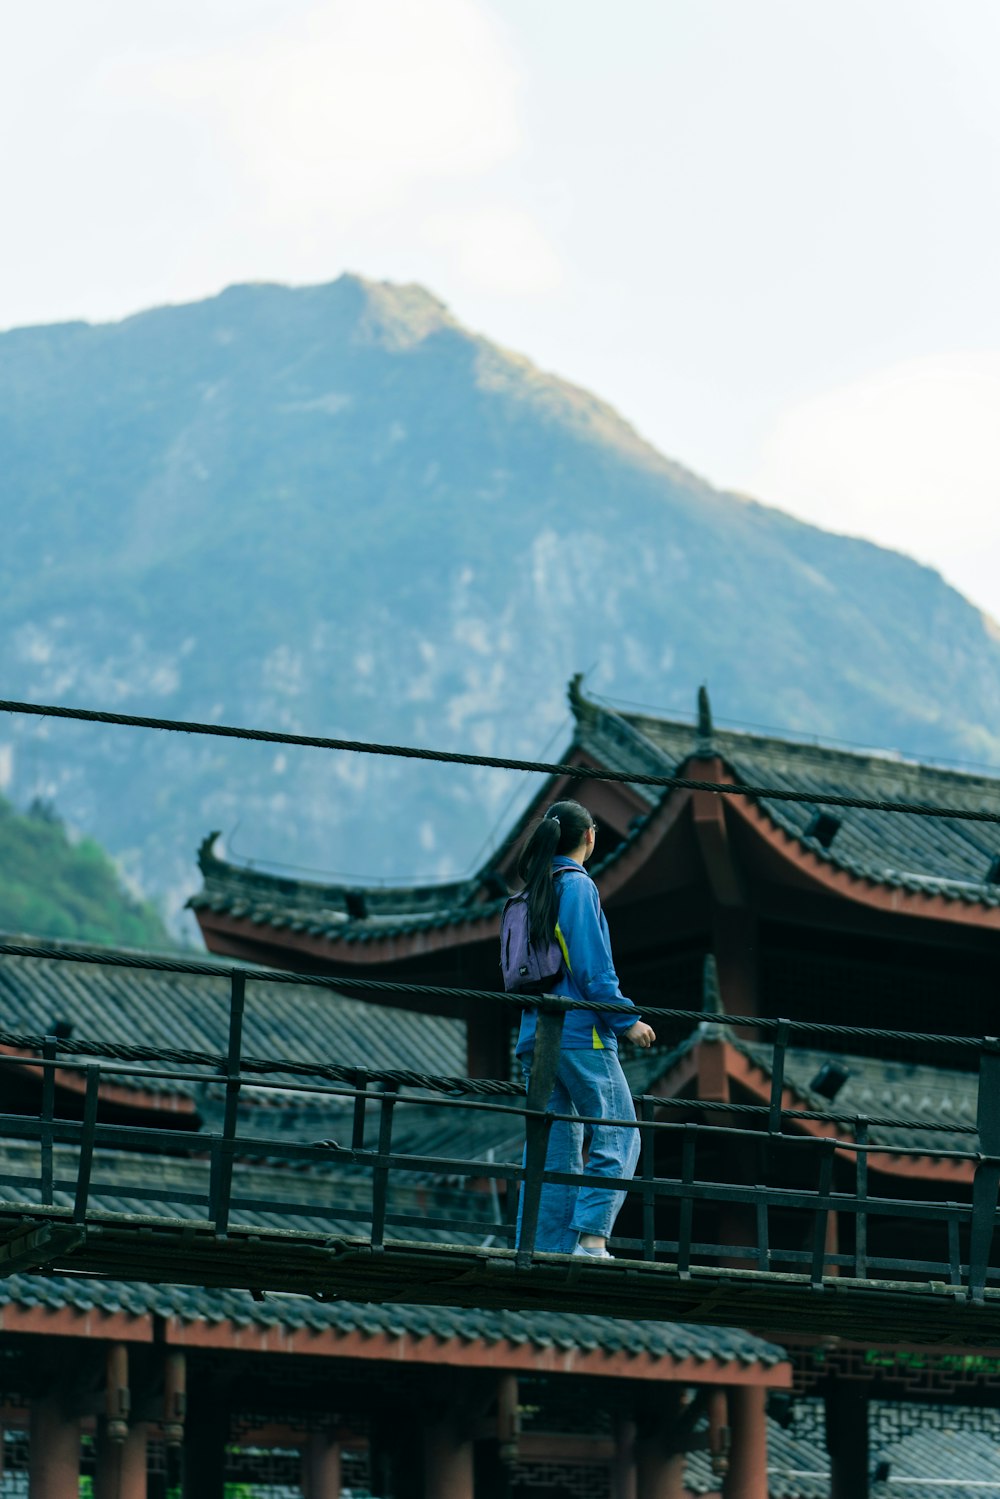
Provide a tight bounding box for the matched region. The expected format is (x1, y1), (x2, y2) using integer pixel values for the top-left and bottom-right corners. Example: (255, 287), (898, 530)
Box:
(516, 854), (642, 1057)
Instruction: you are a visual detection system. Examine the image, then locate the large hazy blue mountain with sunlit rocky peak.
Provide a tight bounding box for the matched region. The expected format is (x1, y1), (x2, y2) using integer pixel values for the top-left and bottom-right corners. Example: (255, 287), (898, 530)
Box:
(0, 276), (1000, 908)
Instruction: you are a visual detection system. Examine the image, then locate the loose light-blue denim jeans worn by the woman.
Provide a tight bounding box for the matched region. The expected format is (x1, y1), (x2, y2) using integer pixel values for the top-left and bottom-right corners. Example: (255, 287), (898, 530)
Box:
(517, 1048), (640, 1255)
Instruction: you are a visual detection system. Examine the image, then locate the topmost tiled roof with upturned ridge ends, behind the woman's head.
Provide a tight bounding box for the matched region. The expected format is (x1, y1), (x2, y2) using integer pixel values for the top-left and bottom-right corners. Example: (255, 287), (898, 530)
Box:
(189, 684), (1000, 943)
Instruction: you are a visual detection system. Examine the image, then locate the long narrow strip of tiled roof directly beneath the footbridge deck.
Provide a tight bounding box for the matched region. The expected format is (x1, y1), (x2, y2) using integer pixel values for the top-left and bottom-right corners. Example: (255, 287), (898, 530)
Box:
(0, 1276), (787, 1369)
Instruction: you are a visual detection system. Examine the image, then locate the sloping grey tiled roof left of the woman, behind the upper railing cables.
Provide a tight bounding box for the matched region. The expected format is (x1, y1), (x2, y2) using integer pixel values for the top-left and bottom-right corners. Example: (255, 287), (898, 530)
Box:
(0, 943), (465, 1085)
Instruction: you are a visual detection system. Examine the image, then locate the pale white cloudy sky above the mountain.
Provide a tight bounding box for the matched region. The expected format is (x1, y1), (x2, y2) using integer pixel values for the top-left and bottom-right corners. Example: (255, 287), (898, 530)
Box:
(0, 0), (1000, 618)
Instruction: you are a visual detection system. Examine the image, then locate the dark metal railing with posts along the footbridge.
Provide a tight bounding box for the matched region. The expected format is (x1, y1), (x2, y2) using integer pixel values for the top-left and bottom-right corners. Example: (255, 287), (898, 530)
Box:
(0, 949), (1000, 1304)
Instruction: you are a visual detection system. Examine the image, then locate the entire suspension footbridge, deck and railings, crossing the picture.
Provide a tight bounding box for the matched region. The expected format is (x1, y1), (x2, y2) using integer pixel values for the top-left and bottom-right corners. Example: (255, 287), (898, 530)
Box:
(0, 970), (1000, 1349)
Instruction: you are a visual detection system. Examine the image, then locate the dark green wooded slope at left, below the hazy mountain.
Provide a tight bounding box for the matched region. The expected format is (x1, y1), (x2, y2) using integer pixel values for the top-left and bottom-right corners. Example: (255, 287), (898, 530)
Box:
(0, 797), (171, 947)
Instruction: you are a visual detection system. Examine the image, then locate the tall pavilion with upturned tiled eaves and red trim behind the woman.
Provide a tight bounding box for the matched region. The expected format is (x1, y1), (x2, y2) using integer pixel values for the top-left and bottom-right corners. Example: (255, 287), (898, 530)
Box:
(192, 681), (1000, 1499)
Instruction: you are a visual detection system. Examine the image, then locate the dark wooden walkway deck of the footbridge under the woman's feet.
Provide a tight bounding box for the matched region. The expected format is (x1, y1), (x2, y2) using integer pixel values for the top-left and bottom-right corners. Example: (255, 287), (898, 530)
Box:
(0, 1205), (1000, 1348)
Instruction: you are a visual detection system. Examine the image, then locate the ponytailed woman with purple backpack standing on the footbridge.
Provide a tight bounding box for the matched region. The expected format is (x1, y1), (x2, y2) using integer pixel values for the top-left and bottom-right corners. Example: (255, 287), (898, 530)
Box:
(517, 802), (657, 1259)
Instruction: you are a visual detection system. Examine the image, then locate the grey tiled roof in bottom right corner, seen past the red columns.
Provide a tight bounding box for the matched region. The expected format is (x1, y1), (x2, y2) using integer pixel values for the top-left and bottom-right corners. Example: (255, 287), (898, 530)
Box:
(685, 1400), (1000, 1499)
